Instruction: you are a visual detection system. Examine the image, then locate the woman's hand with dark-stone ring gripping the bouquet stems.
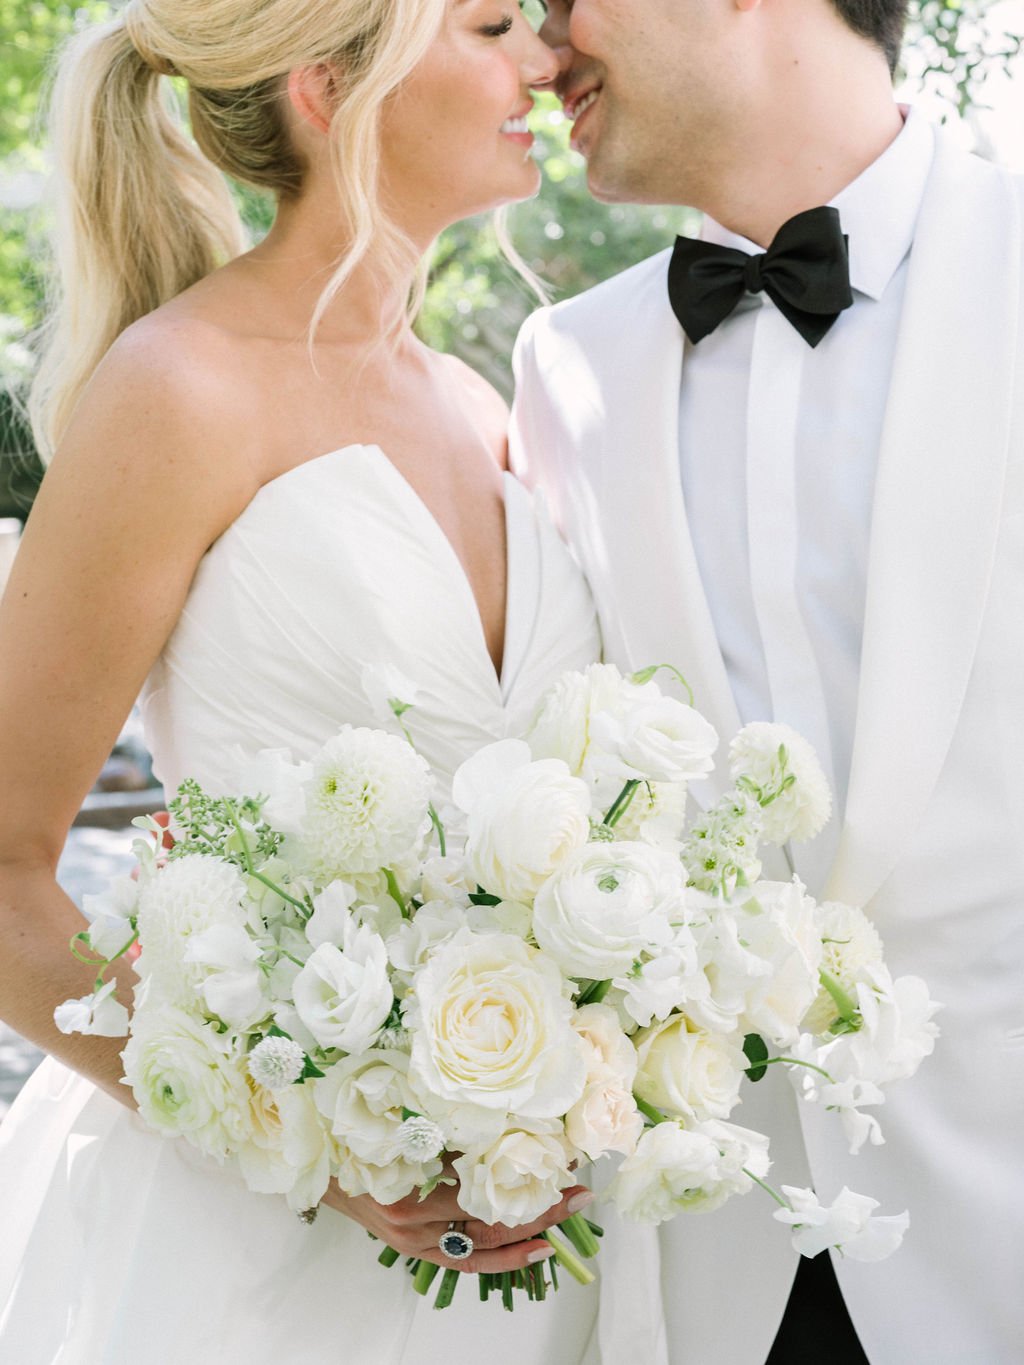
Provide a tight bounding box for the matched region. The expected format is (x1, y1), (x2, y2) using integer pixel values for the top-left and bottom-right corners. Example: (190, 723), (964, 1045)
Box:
(324, 1181), (594, 1275)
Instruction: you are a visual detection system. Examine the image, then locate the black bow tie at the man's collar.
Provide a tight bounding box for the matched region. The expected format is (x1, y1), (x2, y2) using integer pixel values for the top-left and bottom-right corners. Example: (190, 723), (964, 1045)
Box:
(669, 209), (853, 345)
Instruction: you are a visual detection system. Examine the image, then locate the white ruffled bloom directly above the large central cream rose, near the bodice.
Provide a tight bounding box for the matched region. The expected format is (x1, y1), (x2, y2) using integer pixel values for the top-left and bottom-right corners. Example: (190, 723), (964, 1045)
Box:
(452, 740), (590, 904)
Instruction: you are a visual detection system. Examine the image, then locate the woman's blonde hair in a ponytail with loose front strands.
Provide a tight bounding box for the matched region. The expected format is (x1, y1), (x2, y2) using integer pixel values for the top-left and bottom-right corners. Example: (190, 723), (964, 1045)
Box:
(29, 0), (445, 460)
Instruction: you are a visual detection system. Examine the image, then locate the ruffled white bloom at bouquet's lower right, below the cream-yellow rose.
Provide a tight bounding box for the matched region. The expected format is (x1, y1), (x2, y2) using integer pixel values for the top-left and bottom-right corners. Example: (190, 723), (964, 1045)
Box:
(610, 1123), (771, 1223)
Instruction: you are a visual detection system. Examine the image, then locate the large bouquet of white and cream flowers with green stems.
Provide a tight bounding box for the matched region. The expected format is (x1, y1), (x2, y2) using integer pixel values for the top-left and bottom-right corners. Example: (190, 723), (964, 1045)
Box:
(56, 665), (937, 1308)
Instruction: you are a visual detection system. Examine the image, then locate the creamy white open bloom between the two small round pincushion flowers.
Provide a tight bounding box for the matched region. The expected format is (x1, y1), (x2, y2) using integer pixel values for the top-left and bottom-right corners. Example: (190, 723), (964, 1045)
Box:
(314, 1048), (441, 1204)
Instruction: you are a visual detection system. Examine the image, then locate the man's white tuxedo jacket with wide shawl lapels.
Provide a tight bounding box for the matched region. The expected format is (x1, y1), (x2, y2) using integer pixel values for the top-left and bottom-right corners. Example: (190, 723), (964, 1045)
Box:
(513, 122), (1024, 1365)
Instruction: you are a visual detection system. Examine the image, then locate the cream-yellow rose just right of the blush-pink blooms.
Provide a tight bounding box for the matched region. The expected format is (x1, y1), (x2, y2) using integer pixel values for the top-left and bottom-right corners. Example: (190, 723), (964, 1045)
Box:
(634, 1014), (748, 1122)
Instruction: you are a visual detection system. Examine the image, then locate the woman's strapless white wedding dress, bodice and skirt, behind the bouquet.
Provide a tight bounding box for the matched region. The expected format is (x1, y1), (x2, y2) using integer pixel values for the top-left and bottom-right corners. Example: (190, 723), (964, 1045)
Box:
(0, 445), (599, 1365)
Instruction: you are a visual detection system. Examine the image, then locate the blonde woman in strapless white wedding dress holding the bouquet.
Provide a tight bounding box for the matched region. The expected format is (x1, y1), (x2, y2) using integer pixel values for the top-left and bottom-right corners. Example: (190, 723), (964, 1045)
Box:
(0, 0), (598, 1365)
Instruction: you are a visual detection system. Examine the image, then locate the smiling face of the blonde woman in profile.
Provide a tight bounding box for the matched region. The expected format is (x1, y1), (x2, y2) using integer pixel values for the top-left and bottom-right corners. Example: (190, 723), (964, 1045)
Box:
(381, 0), (557, 233)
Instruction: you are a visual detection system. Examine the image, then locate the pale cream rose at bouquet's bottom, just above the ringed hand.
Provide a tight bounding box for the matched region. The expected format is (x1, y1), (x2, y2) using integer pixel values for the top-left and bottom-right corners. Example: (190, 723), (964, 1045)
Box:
(452, 1121), (573, 1227)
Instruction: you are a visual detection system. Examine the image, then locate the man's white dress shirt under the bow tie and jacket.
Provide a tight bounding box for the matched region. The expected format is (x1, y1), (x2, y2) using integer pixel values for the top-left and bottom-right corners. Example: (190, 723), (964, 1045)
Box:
(679, 111), (934, 891)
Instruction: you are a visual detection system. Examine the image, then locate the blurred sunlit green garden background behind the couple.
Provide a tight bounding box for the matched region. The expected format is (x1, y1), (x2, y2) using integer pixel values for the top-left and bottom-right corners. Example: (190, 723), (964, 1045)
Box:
(0, 0), (1024, 1118)
